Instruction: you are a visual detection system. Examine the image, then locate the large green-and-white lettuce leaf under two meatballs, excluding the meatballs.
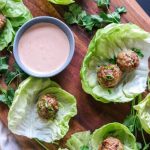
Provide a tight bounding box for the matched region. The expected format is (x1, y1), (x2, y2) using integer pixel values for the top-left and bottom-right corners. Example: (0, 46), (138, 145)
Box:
(80, 24), (150, 103)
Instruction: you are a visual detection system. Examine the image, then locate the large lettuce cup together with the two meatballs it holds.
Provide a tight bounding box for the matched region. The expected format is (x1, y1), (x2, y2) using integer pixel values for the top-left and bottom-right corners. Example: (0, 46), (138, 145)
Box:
(80, 24), (150, 103)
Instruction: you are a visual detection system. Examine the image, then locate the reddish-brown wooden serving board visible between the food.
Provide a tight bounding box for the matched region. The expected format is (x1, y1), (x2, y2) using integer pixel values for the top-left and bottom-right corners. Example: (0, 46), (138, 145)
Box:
(0, 0), (150, 150)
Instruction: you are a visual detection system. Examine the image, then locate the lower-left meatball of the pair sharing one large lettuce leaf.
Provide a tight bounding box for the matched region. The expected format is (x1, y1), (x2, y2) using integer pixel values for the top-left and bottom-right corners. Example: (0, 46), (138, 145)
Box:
(97, 64), (122, 88)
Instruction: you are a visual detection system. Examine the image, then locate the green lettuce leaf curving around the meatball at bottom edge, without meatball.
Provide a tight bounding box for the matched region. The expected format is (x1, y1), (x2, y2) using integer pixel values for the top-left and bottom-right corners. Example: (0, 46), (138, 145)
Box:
(91, 122), (137, 150)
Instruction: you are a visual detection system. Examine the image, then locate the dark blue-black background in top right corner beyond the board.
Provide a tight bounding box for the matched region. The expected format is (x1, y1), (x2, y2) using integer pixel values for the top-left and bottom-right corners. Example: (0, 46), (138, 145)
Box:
(137, 0), (150, 16)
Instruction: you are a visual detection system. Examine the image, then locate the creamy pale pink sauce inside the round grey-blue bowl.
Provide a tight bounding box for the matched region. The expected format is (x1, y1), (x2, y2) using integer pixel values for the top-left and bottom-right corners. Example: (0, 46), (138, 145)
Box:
(18, 22), (70, 74)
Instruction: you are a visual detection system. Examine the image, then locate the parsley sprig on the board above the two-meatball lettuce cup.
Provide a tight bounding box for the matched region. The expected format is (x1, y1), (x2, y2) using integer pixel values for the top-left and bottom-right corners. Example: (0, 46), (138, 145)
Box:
(64, 1), (127, 31)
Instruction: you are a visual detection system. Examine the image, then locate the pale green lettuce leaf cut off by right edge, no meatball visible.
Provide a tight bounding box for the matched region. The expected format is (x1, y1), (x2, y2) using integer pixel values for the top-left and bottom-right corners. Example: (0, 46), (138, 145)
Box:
(134, 94), (150, 134)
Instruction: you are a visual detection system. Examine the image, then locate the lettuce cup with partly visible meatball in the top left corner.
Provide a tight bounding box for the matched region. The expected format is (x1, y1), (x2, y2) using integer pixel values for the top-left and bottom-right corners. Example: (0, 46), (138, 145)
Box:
(0, 0), (32, 51)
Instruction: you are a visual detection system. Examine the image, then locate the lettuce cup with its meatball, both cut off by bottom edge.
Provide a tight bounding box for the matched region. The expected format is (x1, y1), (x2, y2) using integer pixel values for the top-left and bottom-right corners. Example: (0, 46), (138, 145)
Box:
(91, 122), (137, 150)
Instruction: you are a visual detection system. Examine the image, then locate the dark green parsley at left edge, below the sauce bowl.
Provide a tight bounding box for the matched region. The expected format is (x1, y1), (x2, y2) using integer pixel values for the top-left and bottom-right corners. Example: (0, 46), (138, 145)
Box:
(0, 56), (28, 107)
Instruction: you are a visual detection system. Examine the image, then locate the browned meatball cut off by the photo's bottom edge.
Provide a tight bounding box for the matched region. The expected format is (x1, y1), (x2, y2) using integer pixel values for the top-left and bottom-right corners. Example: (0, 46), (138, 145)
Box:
(99, 137), (123, 150)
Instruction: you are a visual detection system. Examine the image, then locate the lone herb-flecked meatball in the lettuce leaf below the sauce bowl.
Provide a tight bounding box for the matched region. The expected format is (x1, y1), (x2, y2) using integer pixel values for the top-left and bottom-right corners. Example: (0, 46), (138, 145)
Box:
(37, 94), (58, 119)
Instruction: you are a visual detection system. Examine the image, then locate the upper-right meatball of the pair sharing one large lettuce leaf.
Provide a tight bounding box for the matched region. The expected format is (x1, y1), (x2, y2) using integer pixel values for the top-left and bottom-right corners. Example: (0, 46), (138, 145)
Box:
(117, 50), (139, 72)
